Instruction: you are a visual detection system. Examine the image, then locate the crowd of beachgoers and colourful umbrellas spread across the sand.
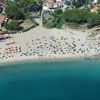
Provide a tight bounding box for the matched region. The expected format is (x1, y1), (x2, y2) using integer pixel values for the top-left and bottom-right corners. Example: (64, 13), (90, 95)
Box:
(0, 30), (100, 60)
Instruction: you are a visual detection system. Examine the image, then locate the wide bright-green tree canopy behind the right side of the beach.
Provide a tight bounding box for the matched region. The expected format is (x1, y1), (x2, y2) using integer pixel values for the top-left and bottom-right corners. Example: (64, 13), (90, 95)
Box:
(63, 9), (88, 24)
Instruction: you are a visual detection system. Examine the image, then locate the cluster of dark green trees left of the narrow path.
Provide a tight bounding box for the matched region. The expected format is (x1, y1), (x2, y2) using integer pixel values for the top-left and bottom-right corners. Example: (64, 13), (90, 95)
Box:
(4, 0), (42, 31)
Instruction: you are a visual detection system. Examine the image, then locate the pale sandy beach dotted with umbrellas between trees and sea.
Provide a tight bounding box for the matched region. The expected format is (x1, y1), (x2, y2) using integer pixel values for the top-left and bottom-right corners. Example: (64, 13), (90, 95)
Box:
(0, 26), (100, 64)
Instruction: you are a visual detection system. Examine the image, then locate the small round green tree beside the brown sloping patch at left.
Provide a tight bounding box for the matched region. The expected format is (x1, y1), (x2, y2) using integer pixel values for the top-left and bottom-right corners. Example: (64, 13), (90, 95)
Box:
(8, 20), (20, 31)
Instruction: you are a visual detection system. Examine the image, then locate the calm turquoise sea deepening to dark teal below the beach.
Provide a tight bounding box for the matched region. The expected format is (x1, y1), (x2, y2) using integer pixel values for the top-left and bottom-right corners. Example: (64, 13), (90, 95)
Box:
(0, 60), (100, 100)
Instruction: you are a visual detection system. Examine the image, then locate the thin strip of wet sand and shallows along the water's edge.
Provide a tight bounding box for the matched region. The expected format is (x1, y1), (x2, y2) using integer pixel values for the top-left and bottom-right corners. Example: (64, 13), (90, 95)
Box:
(0, 55), (84, 67)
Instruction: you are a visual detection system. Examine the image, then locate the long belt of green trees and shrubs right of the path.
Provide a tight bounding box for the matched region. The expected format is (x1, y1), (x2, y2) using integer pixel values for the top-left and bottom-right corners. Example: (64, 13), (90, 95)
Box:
(45, 8), (100, 28)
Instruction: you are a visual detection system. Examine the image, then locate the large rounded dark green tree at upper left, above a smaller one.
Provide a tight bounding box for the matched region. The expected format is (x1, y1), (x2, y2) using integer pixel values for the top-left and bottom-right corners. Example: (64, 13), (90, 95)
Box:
(5, 4), (24, 19)
